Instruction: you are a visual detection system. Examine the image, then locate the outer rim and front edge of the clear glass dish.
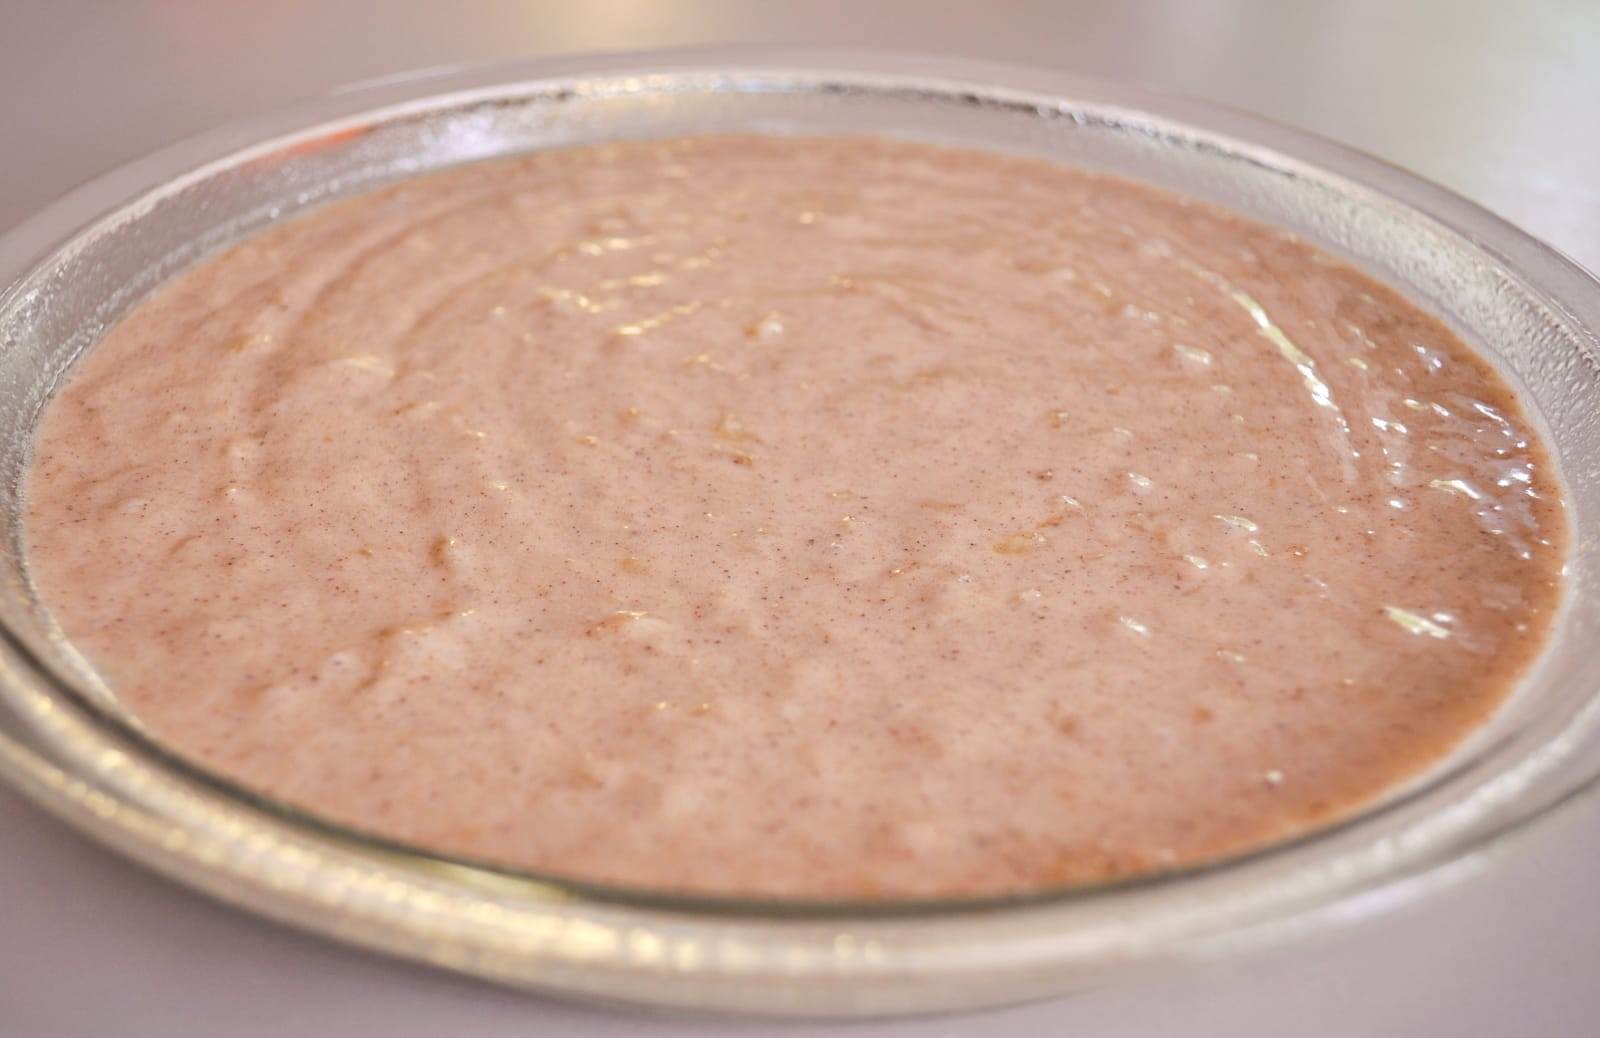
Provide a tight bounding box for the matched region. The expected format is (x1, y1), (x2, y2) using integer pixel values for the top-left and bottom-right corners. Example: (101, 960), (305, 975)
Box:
(0, 48), (1600, 1014)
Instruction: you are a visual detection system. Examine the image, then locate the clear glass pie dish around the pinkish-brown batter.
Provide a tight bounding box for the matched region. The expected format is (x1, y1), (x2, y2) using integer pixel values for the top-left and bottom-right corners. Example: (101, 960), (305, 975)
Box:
(0, 50), (1600, 1016)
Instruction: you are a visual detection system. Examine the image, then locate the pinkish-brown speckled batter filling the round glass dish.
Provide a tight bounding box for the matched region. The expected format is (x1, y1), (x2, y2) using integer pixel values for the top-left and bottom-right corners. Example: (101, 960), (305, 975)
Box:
(27, 136), (1566, 897)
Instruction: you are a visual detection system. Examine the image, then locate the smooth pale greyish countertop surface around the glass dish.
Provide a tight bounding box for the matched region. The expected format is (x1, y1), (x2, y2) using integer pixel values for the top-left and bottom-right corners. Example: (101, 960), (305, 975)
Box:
(0, 0), (1600, 1038)
